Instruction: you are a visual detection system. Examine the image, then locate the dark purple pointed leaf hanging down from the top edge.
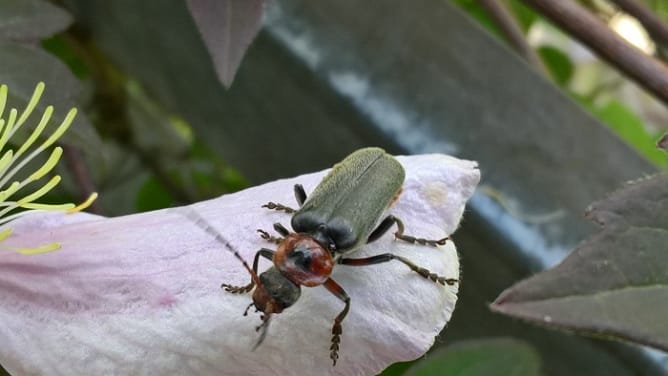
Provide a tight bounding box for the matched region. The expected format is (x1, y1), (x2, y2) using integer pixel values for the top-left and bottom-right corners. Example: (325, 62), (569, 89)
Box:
(187, 0), (264, 87)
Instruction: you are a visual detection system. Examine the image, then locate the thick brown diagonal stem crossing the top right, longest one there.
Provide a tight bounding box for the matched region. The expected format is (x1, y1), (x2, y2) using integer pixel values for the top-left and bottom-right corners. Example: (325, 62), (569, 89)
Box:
(524, 0), (668, 104)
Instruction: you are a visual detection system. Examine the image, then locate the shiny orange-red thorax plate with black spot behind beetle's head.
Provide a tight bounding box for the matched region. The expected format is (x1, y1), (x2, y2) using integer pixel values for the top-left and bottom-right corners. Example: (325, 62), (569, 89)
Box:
(274, 234), (334, 287)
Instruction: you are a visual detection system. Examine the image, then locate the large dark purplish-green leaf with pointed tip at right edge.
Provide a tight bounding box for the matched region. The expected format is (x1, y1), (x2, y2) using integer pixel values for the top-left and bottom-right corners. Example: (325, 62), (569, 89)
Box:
(491, 175), (668, 351)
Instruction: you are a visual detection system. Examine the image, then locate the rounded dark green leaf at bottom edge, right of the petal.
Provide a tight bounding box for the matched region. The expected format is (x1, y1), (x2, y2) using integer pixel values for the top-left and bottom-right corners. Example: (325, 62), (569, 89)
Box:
(405, 338), (542, 376)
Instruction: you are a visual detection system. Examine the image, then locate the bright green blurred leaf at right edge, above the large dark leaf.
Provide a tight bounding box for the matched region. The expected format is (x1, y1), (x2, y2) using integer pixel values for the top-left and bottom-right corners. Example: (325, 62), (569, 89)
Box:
(592, 101), (668, 168)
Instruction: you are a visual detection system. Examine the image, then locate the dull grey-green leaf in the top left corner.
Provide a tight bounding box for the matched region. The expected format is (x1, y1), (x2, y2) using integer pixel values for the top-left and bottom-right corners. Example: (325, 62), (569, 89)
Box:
(0, 0), (72, 42)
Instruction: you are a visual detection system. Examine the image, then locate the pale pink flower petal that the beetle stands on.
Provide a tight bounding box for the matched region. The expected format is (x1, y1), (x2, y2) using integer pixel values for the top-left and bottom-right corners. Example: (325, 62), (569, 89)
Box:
(0, 155), (479, 375)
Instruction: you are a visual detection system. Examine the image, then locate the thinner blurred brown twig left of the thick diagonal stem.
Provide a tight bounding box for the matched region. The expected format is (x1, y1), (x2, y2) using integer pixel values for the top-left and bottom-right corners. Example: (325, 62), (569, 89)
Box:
(478, 0), (549, 76)
